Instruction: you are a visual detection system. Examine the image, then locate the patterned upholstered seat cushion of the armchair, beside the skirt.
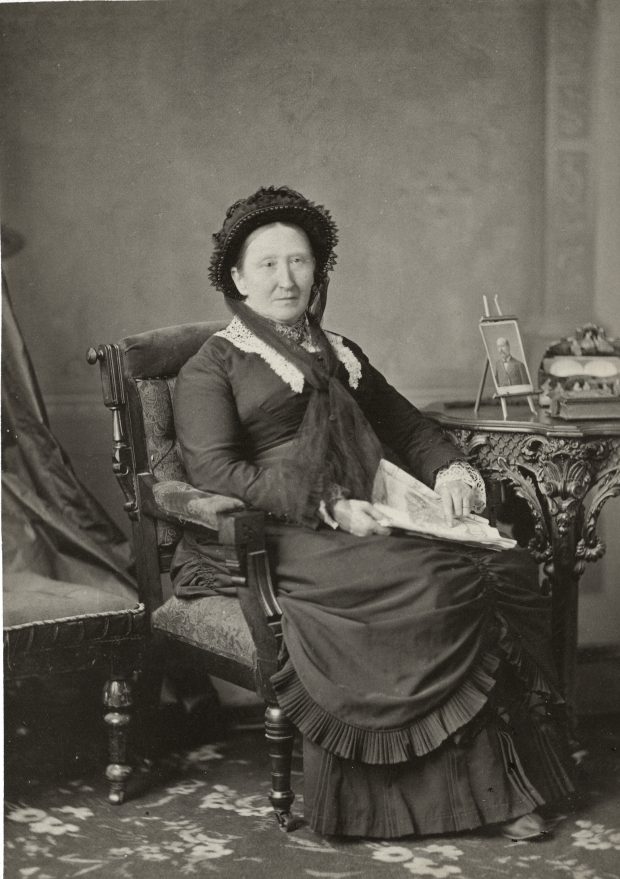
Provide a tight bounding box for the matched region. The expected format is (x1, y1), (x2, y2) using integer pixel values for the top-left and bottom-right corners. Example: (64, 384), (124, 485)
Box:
(152, 595), (256, 668)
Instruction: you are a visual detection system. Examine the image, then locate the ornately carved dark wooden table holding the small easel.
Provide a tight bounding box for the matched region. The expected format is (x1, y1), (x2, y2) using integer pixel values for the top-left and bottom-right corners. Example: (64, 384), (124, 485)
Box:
(427, 403), (620, 720)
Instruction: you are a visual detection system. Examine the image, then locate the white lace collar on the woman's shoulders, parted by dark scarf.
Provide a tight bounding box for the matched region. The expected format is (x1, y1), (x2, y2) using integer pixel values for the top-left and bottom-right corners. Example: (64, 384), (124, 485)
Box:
(215, 315), (362, 394)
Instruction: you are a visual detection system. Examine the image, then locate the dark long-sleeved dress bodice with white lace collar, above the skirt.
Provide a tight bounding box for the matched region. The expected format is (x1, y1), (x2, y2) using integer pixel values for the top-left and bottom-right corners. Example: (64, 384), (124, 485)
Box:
(174, 331), (464, 515)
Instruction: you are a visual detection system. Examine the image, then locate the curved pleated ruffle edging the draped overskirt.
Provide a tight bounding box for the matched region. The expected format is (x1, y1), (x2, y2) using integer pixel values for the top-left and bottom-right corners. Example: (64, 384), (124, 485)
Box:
(271, 653), (500, 765)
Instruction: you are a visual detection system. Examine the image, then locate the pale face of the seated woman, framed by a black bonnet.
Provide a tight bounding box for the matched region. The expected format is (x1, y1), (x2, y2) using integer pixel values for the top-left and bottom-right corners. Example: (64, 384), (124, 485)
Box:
(231, 223), (314, 324)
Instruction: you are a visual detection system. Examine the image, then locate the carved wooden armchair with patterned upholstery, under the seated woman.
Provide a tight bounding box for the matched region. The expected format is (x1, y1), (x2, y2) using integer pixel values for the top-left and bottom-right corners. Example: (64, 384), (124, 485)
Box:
(87, 322), (294, 830)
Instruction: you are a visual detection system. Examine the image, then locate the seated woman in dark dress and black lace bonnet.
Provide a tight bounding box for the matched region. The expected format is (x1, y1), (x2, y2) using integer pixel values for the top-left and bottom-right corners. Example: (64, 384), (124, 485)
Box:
(172, 187), (572, 839)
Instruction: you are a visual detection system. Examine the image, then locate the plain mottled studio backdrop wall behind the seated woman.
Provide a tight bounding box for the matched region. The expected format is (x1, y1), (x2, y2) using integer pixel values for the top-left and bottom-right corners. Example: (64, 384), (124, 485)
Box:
(0, 0), (620, 648)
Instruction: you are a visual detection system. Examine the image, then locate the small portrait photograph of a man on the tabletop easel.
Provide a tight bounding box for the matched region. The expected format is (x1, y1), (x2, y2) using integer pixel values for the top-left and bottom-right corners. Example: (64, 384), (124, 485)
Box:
(480, 316), (534, 397)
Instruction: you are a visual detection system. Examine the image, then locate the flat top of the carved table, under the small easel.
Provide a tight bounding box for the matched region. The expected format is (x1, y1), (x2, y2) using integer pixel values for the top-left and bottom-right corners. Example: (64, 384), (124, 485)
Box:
(424, 399), (620, 439)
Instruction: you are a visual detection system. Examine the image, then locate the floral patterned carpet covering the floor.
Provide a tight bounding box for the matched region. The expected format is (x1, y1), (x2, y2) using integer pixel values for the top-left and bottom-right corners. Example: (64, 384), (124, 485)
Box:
(4, 680), (620, 879)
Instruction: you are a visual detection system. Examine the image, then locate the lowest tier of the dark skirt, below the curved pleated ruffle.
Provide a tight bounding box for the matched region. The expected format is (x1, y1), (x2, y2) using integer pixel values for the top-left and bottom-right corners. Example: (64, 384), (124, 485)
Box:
(303, 668), (574, 839)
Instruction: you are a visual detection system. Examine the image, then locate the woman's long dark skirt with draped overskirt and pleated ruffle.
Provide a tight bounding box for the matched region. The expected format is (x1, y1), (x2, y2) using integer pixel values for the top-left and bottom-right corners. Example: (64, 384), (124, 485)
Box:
(174, 526), (572, 838)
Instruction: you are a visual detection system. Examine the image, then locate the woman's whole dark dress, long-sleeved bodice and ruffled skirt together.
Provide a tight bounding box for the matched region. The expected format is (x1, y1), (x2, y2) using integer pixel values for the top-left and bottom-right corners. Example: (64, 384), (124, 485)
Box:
(172, 319), (572, 838)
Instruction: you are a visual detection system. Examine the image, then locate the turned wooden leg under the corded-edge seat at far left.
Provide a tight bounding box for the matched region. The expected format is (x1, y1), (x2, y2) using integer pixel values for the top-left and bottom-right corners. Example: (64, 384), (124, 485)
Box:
(103, 677), (133, 804)
